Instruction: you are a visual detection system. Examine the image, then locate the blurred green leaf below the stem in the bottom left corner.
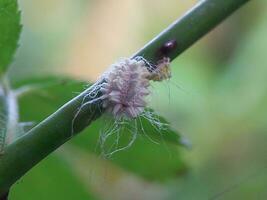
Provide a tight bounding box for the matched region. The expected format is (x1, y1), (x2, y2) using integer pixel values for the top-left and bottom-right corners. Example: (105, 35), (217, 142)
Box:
(9, 155), (99, 200)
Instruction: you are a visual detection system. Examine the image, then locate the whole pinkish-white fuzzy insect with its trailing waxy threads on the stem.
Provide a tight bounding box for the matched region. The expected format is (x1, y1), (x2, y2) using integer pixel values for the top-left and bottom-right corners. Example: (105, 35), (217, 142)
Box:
(72, 57), (174, 156)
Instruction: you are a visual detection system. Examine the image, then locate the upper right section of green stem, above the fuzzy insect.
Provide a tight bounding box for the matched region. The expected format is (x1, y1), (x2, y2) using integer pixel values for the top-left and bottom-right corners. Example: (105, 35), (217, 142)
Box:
(134, 0), (249, 63)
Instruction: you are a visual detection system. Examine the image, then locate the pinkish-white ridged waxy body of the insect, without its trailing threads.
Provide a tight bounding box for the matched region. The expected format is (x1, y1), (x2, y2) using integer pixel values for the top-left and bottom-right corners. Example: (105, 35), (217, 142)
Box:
(101, 58), (149, 118)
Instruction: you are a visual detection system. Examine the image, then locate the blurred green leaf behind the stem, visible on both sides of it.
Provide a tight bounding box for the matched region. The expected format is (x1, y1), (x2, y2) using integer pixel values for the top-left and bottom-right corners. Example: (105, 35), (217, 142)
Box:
(14, 78), (186, 180)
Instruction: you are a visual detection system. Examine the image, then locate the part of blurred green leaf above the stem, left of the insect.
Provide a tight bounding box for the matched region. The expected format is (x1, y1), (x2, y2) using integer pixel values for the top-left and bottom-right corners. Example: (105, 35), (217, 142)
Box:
(13, 77), (87, 124)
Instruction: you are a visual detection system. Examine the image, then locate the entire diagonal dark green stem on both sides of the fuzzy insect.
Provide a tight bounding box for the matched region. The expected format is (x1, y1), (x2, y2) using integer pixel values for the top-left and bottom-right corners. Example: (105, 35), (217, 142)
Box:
(0, 0), (249, 194)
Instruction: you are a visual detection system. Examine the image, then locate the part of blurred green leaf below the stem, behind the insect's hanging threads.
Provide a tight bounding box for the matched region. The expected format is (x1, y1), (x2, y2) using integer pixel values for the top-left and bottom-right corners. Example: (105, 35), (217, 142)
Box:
(72, 113), (186, 181)
